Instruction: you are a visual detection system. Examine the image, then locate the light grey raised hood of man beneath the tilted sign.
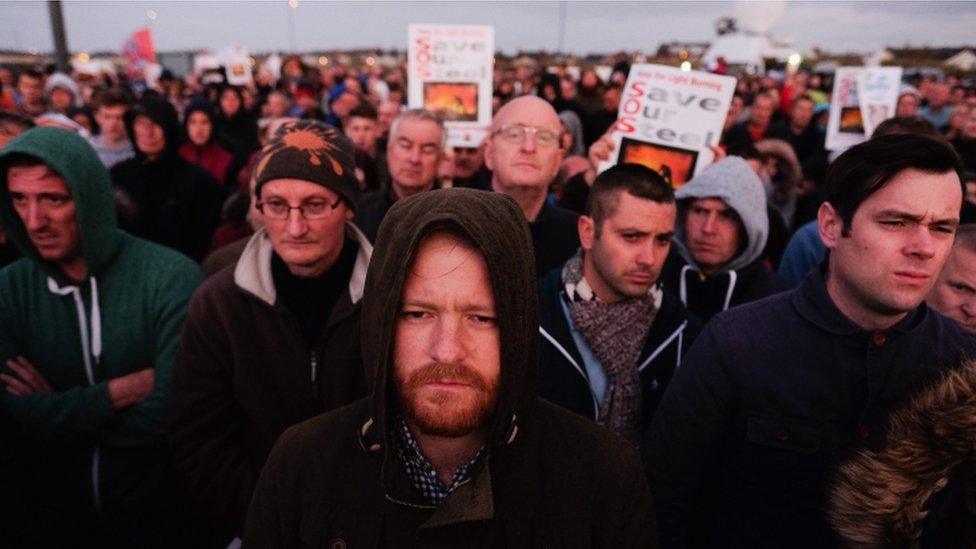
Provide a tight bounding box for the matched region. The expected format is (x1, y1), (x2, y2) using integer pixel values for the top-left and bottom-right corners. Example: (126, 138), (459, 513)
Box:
(674, 156), (769, 272)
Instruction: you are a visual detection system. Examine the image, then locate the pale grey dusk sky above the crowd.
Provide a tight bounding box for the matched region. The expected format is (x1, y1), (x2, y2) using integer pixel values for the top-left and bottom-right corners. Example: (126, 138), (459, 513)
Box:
(0, 0), (976, 54)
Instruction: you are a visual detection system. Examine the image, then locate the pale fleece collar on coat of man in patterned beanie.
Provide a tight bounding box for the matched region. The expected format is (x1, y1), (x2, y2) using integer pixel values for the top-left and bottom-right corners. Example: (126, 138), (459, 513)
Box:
(234, 222), (373, 306)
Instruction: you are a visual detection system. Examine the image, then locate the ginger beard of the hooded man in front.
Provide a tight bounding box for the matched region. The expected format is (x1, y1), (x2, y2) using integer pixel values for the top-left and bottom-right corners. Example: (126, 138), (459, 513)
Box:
(395, 363), (498, 438)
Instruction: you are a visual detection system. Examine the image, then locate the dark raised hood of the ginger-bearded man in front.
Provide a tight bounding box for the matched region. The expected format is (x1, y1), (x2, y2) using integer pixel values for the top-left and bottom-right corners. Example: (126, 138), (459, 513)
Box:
(362, 188), (539, 458)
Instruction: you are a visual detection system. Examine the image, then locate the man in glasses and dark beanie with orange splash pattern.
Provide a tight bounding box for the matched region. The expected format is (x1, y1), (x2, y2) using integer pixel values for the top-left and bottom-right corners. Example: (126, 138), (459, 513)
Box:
(170, 120), (372, 536)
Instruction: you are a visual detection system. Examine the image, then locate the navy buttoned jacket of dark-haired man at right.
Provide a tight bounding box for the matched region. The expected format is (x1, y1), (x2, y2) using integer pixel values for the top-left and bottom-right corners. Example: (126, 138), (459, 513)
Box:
(643, 268), (976, 548)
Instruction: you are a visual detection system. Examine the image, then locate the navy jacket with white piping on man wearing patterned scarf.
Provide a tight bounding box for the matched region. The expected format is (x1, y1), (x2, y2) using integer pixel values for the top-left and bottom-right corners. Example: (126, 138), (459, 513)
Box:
(539, 267), (701, 431)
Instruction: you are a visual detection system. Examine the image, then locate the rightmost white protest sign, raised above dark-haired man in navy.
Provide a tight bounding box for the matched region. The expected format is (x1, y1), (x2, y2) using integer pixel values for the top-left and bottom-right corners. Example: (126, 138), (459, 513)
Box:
(826, 67), (902, 151)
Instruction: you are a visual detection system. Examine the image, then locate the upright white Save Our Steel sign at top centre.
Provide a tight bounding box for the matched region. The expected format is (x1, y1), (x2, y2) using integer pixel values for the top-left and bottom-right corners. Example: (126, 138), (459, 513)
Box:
(407, 24), (495, 147)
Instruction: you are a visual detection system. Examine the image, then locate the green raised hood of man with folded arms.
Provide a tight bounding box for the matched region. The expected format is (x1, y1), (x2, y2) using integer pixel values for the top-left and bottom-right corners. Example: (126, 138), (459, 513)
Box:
(0, 127), (119, 285)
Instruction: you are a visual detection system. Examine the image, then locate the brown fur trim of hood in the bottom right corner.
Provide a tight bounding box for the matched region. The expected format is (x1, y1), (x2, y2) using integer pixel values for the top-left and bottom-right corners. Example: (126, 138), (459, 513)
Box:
(828, 359), (976, 548)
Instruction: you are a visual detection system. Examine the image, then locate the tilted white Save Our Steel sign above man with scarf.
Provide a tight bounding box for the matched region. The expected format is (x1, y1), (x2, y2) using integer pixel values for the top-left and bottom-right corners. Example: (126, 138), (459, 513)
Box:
(600, 65), (735, 188)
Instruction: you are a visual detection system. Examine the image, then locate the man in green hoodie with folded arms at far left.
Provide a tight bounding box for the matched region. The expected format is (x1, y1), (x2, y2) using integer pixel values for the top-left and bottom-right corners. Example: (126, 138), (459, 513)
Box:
(0, 128), (201, 547)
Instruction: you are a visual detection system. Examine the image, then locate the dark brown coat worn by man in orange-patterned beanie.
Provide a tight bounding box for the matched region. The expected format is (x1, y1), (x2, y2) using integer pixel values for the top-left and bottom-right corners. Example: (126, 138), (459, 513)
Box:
(170, 231), (369, 535)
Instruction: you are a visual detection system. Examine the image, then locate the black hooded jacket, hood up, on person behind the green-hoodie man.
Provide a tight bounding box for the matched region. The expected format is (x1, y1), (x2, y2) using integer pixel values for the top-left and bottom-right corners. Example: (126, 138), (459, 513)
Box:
(112, 98), (220, 261)
